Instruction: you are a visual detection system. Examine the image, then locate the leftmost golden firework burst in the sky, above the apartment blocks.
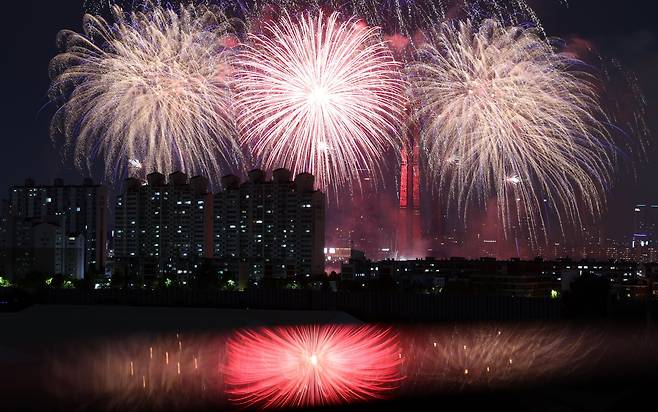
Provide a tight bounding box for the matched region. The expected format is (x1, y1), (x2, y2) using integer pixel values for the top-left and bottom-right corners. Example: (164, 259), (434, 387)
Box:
(50, 5), (240, 186)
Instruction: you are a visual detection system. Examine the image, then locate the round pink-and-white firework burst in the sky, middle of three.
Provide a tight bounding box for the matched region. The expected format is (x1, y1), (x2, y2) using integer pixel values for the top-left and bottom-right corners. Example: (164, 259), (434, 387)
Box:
(231, 12), (406, 195)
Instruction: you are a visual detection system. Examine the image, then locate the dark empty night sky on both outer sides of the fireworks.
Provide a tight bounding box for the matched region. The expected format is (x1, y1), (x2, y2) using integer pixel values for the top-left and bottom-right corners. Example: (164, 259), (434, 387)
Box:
(0, 0), (658, 238)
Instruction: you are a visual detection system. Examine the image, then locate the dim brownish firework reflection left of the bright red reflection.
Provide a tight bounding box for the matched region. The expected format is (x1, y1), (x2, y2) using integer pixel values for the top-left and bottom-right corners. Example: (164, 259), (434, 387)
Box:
(50, 334), (224, 410)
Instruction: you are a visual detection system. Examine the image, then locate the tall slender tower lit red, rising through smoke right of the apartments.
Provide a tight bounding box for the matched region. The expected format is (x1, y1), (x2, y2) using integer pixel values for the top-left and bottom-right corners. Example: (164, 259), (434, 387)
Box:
(395, 119), (424, 258)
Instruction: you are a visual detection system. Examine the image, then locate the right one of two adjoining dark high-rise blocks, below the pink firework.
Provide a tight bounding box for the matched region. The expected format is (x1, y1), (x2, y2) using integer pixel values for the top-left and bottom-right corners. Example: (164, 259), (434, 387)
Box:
(213, 169), (325, 279)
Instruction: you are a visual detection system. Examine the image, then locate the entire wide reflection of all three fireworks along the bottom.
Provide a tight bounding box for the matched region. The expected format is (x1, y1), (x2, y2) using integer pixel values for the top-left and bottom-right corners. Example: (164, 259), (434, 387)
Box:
(46, 325), (605, 411)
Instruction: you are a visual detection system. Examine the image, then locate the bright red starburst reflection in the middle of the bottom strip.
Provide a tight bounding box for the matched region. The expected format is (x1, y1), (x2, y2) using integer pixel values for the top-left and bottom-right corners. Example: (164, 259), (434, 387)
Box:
(225, 325), (402, 409)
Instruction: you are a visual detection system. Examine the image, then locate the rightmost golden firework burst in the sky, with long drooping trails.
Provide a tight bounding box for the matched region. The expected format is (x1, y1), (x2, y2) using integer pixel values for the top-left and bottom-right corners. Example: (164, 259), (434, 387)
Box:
(408, 20), (614, 238)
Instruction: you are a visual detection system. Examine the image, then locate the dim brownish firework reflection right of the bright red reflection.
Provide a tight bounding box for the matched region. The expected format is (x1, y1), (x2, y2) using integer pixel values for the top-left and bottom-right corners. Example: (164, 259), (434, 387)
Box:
(401, 326), (600, 391)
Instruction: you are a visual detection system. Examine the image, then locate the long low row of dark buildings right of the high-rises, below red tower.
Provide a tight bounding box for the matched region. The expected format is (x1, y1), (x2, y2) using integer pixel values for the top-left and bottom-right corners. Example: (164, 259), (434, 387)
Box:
(340, 256), (658, 301)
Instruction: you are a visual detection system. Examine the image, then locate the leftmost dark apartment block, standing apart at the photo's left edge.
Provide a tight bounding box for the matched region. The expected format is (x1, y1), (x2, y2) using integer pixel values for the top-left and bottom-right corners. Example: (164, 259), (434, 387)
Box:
(3, 179), (107, 278)
